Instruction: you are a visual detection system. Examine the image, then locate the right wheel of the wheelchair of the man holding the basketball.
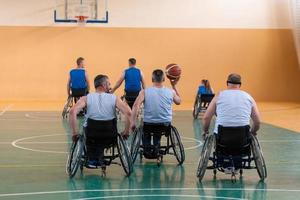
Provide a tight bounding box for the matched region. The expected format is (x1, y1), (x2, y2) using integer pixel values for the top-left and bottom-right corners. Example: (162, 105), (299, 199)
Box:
(170, 126), (185, 165)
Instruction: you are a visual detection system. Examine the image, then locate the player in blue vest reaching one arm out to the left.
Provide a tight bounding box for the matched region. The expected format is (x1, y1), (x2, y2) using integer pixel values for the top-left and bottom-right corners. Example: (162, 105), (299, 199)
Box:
(111, 58), (145, 109)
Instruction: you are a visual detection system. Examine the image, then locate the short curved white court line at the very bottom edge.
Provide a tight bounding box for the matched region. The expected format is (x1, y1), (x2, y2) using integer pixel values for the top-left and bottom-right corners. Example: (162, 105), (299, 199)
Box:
(73, 194), (247, 200)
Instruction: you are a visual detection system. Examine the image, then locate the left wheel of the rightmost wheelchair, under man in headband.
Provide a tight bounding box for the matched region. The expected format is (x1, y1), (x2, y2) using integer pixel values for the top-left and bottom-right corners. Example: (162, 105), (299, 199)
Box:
(197, 134), (215, 181)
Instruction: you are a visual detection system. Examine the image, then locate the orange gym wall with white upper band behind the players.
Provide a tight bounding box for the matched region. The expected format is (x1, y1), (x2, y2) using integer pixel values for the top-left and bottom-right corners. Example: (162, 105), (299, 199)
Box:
(0, 0), (300, 105)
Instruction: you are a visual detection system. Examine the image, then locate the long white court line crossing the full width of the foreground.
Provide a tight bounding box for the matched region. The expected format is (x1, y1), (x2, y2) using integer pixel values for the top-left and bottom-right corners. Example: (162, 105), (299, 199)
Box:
(0, 188), (300, 197)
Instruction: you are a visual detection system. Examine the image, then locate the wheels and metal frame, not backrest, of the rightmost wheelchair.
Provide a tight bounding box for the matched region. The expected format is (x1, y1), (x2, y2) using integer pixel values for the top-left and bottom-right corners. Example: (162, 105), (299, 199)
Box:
(196, 134), (267, 181)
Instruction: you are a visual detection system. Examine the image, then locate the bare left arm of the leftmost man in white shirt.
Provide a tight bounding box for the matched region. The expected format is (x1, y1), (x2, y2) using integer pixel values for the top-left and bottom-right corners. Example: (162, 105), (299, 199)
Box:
(69, 96), (87, 141)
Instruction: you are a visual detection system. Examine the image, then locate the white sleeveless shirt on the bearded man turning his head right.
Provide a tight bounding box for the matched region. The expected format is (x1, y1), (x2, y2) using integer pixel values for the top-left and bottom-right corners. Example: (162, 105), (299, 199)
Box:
(85, 92), (117, 126)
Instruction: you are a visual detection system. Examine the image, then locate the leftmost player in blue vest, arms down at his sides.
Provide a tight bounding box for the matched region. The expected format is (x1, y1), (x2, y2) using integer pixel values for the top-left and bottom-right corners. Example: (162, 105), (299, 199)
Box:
(67, 57), (90, 103)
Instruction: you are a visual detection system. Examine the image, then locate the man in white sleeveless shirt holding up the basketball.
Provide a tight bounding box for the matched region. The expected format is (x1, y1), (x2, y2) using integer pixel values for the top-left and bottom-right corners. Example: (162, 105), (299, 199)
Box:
(131, 69), (181, 158)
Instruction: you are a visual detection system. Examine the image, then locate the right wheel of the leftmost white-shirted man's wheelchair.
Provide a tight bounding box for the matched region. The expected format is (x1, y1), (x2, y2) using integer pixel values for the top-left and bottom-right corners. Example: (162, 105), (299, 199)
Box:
(117, 134), (133, 176)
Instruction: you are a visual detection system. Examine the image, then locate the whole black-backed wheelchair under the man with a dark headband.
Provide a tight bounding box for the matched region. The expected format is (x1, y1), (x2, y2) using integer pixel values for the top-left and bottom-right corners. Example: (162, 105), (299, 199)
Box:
(197, 126), (267, 182)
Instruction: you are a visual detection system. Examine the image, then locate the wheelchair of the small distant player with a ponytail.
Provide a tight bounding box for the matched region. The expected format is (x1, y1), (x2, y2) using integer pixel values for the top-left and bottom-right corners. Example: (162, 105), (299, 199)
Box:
(193, 94), (215, 119)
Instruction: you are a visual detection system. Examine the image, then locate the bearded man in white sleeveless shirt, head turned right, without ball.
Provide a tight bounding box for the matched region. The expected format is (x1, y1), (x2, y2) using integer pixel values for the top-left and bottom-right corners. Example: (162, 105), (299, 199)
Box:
(70, 75), (131, 168)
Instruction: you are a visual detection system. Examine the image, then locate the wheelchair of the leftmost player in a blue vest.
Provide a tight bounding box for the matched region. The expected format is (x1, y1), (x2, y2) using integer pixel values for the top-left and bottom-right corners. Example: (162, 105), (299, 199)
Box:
(61, 89), (88, 119)
